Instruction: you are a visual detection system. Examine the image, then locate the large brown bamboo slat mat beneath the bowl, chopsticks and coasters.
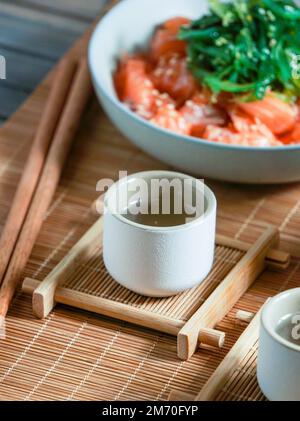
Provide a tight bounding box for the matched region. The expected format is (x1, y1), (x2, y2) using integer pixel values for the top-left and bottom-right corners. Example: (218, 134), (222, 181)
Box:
(0, 0), (300, 400)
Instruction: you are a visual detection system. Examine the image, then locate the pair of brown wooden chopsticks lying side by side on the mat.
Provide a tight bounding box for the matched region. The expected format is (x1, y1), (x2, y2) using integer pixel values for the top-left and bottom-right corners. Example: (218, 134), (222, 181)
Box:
(0, 58), (92, 327)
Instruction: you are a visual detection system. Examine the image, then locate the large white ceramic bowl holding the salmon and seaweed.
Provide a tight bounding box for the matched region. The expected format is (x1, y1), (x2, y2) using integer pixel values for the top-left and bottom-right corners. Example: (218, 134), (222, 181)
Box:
(89, 0), (300, 183)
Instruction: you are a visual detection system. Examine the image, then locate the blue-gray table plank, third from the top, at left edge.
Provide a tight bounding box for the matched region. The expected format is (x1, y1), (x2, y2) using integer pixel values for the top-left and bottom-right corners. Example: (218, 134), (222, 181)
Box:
(0, 48), (54, 92)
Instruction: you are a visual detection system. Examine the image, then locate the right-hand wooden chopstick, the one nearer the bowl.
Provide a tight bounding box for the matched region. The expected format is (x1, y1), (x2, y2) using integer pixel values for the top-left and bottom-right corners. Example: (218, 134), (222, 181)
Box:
(0, 59), (92, 326)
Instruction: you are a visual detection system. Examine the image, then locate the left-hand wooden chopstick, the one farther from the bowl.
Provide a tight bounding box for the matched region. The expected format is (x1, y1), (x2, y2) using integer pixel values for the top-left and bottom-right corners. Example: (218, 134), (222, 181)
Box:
(0, 59), (76, 285)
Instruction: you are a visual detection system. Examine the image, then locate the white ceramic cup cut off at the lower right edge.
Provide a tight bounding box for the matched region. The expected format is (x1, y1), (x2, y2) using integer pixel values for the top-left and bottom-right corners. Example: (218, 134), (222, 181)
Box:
(257, 288), (300, 401)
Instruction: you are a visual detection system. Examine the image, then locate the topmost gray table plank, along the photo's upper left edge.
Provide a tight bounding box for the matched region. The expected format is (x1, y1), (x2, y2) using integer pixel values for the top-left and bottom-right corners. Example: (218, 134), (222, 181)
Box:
(4, 0), (107, 21)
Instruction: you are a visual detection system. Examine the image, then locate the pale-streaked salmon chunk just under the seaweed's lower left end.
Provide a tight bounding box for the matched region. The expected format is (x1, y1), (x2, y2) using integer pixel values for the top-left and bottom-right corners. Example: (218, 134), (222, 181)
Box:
(180, 92), (227, 137)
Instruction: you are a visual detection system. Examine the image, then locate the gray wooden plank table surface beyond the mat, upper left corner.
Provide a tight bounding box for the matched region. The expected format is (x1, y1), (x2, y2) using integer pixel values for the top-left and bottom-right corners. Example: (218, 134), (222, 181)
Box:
(0, 0), (106, 124)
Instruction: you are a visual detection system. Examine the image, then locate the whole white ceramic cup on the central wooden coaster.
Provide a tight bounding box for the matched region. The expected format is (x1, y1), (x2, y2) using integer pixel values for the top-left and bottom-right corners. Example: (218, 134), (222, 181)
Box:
(103, 171), (216, 297)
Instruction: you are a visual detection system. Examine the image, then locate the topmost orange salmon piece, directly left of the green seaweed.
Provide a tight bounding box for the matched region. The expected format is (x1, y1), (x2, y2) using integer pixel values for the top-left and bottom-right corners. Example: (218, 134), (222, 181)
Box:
(150, 17), (190, 61)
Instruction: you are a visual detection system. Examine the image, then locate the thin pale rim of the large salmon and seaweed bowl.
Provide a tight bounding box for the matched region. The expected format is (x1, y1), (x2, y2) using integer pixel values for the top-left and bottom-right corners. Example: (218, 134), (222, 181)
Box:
(88, 0), (300, 153)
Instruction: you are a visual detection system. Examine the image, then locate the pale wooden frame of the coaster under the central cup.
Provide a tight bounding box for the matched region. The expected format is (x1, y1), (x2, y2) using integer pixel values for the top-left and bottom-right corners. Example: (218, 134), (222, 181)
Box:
(22, 218), (289, 360)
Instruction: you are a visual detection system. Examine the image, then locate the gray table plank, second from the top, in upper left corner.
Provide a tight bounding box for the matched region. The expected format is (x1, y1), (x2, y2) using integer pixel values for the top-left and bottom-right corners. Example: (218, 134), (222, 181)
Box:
(0, 12), (82, 60)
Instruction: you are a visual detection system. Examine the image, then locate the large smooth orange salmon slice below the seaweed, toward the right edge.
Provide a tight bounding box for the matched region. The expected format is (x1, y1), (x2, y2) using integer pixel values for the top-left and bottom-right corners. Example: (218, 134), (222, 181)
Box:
(238, 94), (298, 134)
